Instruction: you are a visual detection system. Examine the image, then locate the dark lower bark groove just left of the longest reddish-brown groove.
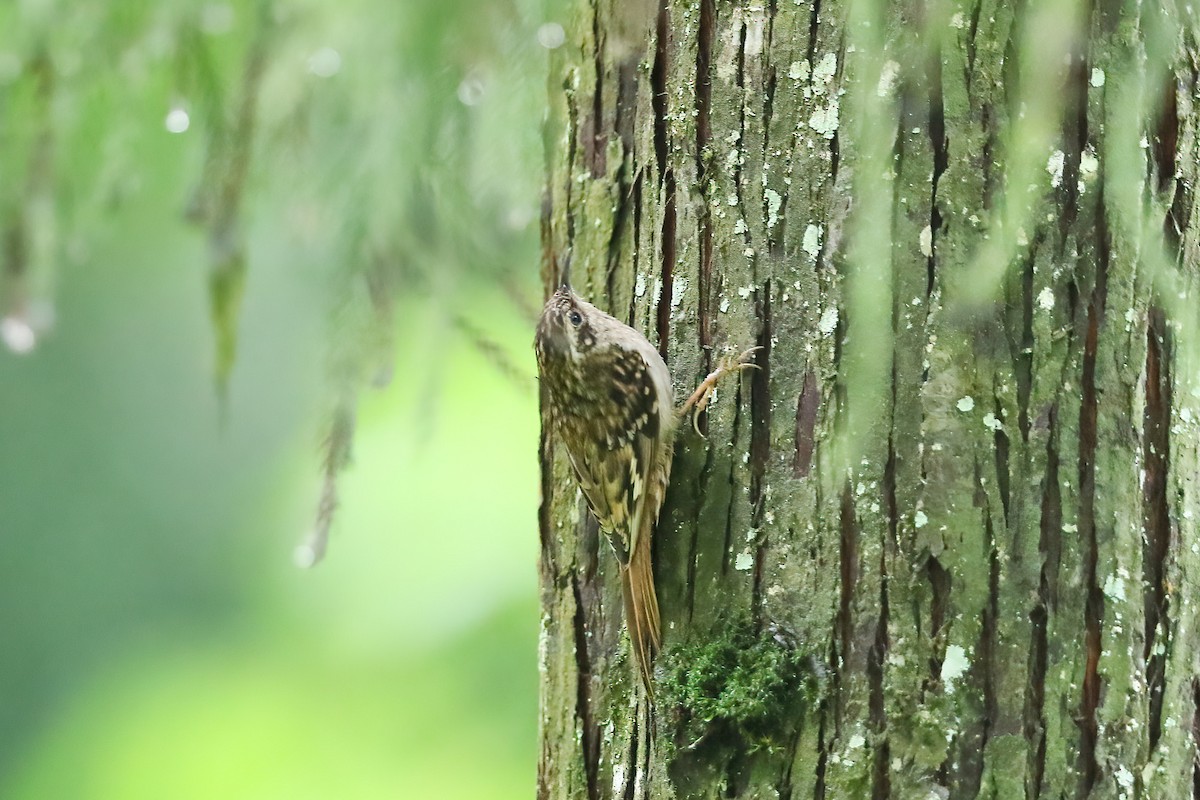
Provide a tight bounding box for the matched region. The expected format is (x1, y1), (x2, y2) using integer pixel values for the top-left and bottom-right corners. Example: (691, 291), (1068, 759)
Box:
(1025, 405), (1062, 800)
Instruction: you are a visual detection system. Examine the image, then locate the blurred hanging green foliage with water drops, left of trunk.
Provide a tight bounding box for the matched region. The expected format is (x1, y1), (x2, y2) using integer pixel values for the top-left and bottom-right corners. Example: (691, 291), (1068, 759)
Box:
(0, 0), (558, 557)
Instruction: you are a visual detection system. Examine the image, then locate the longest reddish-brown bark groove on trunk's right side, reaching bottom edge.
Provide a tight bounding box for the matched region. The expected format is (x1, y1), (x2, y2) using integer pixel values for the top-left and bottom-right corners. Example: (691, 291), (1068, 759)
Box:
(1079, 203), (1112, 798)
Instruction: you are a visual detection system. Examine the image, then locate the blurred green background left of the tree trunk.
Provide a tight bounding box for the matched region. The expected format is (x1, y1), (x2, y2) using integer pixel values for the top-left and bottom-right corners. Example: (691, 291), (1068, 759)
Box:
(0, 0), (552, 800)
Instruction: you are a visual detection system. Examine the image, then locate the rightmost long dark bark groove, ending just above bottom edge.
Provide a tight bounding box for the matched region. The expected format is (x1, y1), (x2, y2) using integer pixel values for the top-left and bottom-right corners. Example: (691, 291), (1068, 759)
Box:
(1142, 307), (1171, 750)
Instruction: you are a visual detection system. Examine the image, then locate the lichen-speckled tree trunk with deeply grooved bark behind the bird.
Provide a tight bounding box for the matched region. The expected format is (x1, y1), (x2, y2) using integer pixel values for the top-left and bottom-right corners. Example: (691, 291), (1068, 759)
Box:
(539, 0), (1200, 800)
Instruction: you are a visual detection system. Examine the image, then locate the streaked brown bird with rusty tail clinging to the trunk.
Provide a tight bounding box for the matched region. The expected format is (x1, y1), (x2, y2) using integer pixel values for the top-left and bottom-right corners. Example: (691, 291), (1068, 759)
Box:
(534, 285), (754, 694)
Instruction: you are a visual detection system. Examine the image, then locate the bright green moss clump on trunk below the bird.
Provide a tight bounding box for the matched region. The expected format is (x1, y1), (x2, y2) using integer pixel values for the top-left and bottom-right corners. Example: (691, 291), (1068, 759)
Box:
(659, 619), (815, 756)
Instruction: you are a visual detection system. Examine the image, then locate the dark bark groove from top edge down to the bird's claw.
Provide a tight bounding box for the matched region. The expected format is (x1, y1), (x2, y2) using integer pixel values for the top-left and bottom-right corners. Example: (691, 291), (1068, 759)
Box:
(696, 0), (716, 371)
